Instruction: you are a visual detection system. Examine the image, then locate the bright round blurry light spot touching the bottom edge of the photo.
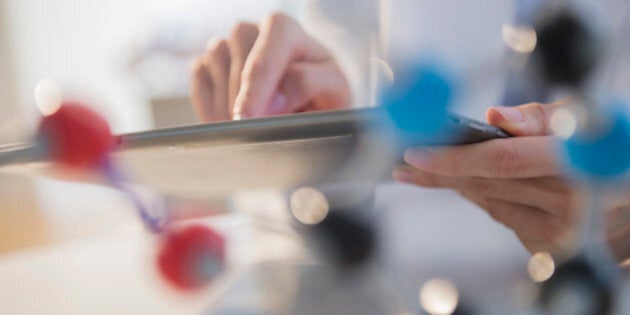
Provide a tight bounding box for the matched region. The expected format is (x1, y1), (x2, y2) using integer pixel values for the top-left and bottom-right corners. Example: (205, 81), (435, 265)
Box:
(420, 278), (459, 315)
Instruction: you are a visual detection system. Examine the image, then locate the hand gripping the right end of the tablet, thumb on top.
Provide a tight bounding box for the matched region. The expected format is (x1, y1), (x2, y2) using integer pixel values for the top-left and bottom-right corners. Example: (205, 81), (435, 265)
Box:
(394, 103), (581, 255)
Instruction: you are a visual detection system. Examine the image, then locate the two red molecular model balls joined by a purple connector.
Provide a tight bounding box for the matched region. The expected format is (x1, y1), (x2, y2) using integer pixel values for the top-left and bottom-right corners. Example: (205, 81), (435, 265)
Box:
(37, 102), (225, 290)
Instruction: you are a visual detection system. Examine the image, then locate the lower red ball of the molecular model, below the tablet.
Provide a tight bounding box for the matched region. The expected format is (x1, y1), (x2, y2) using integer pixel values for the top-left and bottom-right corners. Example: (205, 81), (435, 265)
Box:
(157, 225), (225, 290)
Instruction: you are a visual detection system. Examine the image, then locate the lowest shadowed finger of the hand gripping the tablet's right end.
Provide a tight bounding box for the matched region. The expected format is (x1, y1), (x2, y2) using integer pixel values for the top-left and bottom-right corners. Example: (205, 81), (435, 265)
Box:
(460, 191), (567, 244)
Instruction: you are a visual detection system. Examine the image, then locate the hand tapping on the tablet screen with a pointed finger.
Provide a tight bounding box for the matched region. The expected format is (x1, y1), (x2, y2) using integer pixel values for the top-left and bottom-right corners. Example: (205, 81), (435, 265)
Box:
(191, 13), (350, 121)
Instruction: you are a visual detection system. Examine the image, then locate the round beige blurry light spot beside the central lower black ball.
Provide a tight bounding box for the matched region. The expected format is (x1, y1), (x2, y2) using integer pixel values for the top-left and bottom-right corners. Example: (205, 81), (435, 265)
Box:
(289, 187), (330, 225)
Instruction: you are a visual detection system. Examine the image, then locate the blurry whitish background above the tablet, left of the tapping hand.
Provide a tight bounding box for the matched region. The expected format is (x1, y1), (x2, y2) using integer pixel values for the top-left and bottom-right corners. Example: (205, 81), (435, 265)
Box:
(0, 0), (308, 143)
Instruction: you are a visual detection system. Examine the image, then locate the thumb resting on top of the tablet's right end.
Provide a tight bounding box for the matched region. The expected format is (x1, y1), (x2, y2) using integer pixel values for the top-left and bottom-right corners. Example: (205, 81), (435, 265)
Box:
(486, 101), (566, 136)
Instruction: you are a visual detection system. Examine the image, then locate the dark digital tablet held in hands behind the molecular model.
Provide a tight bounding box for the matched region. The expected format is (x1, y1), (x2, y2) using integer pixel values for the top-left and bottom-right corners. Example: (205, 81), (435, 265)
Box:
(0, 108), (509, 199)
